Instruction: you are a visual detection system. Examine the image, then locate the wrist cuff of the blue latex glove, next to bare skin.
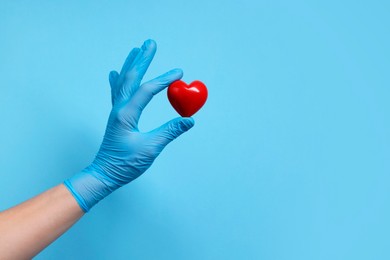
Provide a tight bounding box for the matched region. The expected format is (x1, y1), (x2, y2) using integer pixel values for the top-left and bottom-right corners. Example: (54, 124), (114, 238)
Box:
(64, 166), (120, 213)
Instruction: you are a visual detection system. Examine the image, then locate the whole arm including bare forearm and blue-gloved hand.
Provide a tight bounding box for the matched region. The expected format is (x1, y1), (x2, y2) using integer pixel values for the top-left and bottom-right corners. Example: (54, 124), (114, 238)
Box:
(0, 40), (194, 260)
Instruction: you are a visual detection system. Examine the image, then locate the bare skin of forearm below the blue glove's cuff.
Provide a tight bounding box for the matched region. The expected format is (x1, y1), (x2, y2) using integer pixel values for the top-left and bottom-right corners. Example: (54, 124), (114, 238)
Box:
(0, 184), (84, 260)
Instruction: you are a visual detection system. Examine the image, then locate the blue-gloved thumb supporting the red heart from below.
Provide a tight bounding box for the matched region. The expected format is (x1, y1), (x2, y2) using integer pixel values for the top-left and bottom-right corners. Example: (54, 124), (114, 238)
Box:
(153, 117), (195, 146)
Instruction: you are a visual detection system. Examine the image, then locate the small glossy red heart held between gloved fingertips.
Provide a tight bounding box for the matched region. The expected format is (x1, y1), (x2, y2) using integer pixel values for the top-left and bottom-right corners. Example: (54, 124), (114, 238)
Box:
(168, 80), (207, 117)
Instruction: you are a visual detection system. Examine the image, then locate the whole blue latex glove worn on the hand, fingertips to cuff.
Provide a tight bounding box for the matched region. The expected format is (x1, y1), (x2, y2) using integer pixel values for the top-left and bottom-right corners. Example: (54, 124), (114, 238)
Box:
(64, 40), (194, 212)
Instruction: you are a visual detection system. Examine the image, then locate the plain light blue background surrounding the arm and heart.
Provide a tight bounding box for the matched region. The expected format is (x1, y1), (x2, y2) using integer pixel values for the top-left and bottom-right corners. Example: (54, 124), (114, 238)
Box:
(0, 0), (390, 260)
